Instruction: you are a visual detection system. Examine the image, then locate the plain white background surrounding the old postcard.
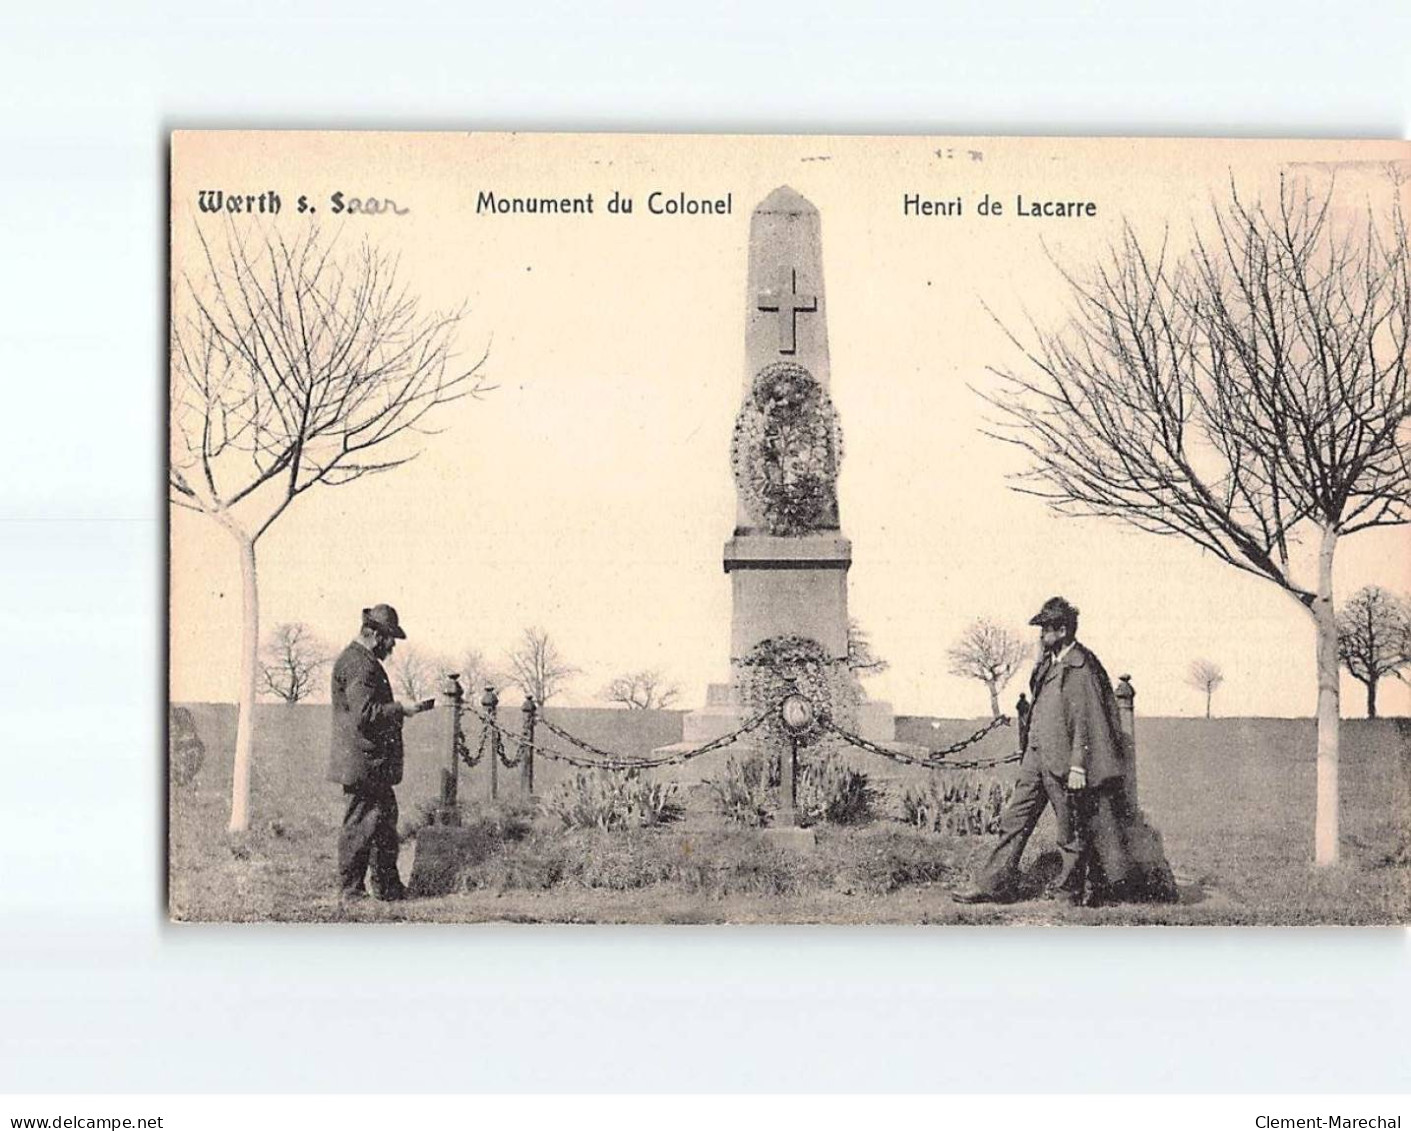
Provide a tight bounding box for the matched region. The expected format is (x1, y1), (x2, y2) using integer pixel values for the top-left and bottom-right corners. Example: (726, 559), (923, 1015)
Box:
(0, 0), (1411, 1094)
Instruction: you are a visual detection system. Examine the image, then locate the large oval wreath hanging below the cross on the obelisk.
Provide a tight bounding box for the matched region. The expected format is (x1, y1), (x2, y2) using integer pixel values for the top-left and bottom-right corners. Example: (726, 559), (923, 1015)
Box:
(731, 361), (842, 534)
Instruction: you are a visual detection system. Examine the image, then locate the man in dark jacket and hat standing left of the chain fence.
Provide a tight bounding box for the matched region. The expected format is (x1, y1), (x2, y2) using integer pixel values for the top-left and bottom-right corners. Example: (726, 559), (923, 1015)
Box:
(329, 605), (433, 900)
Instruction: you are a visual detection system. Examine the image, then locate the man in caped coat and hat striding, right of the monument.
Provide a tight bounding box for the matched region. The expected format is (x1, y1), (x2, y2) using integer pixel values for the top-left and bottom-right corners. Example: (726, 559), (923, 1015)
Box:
(954, 597), (1127, 904)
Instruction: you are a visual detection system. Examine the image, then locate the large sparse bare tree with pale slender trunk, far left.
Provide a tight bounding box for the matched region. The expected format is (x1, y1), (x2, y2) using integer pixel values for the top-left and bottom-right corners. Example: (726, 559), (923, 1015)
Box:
(168, 224), (485, 831)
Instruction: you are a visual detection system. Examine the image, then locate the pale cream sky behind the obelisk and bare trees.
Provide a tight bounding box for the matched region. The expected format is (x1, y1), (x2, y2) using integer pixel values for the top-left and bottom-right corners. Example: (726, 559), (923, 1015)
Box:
(171, 133), (1411, 716)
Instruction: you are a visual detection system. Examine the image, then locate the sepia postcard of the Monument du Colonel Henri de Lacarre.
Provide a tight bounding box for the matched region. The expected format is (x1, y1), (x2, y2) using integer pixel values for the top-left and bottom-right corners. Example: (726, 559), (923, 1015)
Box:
(166, 131), (1411, 927)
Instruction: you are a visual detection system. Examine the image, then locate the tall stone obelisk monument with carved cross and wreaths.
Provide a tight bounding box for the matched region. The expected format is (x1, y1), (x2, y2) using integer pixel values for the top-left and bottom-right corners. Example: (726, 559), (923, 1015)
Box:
(659, 186), (896, 776)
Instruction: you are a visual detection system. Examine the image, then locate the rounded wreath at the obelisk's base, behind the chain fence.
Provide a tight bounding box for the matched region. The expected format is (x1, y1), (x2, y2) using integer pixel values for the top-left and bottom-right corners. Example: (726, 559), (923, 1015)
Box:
(731, 633), (861, 753)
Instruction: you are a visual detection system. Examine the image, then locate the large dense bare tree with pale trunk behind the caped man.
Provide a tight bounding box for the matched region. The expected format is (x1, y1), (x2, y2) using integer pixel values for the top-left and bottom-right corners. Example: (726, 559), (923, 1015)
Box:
(986, 182), (1411, 864)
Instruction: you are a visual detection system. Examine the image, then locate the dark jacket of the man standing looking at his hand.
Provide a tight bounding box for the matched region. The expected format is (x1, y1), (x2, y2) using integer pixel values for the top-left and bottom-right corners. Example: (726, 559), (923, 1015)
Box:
(329, 642), (404, 785)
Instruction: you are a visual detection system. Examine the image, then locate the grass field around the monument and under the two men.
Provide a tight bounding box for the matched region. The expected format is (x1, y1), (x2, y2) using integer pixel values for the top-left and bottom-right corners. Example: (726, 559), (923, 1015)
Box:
(169, 705), (1411, 925)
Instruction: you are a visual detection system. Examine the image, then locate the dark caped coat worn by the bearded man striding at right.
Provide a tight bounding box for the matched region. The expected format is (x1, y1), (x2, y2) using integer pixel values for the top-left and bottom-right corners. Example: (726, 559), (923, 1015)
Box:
(1024, 642), (1127, 787)
